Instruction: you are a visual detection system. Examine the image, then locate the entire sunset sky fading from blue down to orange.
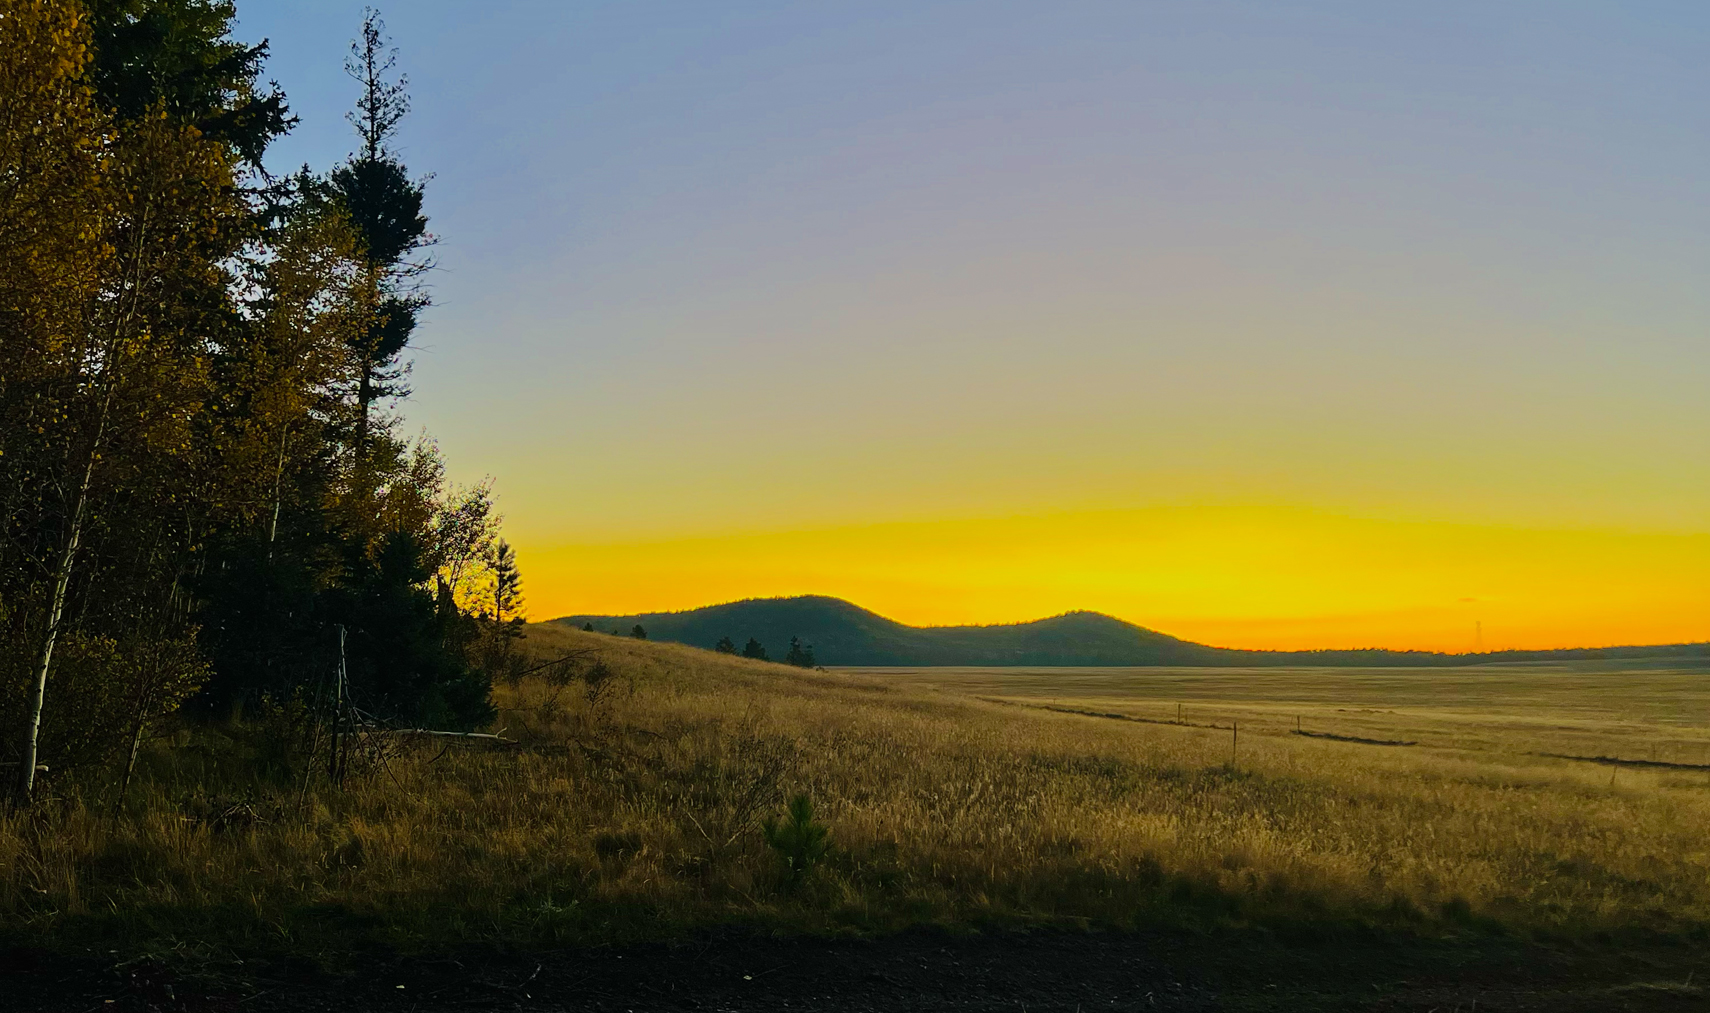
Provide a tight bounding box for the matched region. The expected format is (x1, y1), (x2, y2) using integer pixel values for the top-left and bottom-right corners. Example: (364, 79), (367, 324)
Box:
(239, 0), (1710, 650)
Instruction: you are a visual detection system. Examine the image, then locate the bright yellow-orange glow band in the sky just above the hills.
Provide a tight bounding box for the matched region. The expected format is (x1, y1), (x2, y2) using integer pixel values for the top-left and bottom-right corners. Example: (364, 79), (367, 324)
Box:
(520, 507), (1710, 652)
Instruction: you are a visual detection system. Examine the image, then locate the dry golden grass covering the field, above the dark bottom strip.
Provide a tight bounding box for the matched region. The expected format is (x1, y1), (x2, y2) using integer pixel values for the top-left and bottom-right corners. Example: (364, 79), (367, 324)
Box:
(0, 626), (1710, 955)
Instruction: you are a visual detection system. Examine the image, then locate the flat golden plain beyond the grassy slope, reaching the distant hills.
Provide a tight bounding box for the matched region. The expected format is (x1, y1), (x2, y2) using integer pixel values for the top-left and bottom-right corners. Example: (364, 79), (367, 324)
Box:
(851, 661), (1710, 770)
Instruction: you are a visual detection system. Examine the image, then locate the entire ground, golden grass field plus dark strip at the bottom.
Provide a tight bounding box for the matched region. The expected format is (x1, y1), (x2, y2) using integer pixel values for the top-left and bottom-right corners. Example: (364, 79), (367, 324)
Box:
(13, 628), (1710, 1013)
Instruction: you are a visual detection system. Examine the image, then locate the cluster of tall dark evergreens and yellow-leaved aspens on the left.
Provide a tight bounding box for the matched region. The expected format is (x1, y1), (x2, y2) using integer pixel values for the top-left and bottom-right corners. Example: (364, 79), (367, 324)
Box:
(0, 0), (522, 796)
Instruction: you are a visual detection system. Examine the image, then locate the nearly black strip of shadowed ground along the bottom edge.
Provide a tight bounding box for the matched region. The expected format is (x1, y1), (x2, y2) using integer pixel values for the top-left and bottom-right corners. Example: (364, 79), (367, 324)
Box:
(0, 931), (1710, 1013)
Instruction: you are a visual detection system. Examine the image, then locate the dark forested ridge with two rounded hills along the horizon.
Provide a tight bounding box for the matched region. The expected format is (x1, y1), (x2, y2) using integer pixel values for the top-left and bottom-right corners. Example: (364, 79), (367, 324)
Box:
(552, 595), (1710, 667)
